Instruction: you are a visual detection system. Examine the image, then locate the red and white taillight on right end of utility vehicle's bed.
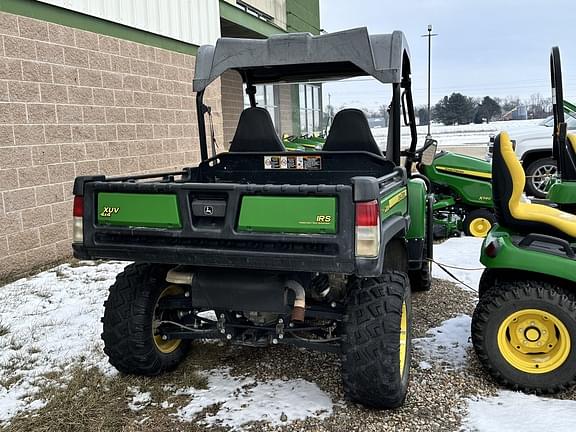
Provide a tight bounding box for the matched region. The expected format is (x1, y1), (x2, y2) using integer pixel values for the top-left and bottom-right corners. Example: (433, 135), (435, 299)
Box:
(356, 200), (380, 257)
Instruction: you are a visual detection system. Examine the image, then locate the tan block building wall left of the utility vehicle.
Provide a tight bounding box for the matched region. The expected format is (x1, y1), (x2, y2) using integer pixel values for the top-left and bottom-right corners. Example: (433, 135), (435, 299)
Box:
(0, 12), (222, 278)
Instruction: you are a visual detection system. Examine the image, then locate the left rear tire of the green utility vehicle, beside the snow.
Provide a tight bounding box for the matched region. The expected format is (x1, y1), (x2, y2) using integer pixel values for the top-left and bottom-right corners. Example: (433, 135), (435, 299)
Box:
(102, 263), (190, 376)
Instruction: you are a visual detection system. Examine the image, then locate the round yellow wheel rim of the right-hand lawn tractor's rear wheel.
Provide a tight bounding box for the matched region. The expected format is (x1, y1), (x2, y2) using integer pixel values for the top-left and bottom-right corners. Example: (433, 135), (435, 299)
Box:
(498, 309), (571, 374)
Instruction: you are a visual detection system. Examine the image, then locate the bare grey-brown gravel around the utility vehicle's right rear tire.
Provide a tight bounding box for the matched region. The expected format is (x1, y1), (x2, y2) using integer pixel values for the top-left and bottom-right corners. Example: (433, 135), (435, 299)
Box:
(168, 279), (497, 432)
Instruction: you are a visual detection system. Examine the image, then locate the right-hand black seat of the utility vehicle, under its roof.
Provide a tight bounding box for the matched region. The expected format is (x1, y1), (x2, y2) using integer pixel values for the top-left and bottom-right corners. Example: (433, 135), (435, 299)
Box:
(322, 108), (384, 157)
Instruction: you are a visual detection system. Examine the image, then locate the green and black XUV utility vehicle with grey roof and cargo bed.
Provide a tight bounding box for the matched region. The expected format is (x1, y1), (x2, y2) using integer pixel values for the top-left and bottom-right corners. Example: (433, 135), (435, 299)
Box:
(73, 28), (432, 408)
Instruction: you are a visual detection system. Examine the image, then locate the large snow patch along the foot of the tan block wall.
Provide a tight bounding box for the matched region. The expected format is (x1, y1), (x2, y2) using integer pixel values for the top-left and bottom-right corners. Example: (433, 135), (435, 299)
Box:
(0, 262), (126, 423)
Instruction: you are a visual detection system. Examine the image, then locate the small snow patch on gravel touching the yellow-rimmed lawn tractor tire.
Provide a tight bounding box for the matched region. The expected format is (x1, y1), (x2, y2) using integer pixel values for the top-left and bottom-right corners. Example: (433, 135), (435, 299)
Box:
(414, 315), (472, 370)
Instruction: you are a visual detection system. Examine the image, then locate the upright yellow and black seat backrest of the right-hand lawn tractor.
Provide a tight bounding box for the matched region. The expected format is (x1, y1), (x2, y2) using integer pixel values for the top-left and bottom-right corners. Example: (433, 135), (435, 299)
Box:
(492, 132), (526, 228)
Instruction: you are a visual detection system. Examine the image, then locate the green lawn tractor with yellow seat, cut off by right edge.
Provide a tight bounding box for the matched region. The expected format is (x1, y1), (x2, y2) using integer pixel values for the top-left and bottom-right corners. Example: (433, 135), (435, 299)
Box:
(472, 48), (576, 393)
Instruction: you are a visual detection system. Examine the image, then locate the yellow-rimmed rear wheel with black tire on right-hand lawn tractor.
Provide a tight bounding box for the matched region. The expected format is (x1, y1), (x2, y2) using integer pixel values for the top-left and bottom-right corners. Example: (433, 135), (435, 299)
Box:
(472, 280), (576, 393)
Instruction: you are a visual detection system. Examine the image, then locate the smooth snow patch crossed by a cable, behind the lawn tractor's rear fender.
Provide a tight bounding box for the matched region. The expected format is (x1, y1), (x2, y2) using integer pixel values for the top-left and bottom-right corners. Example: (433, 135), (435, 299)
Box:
(432, 237), (484, 290)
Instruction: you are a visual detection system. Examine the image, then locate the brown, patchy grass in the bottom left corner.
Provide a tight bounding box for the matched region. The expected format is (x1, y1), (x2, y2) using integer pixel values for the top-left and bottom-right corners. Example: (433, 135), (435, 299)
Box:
(2, 349), (220, 432)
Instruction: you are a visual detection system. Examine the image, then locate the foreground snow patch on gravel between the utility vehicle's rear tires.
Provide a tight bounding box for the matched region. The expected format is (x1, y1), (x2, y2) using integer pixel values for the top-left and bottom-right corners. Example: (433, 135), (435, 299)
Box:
(175, 369), (333, 430)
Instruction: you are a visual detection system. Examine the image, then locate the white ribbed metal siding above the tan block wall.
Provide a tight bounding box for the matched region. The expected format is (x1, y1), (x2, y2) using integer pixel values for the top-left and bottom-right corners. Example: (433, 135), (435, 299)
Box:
(38, 0), (220, 45)
